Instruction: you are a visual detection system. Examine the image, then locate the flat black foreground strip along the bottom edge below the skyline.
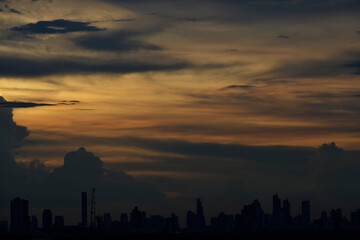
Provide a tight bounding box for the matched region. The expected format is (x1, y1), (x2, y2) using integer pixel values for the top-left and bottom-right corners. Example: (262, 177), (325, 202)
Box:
(0, 232), (360, 240)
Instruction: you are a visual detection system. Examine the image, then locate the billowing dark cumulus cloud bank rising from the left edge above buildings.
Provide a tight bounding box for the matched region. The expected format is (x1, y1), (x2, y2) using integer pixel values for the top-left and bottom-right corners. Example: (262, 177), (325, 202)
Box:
(0, 98), (164, 208)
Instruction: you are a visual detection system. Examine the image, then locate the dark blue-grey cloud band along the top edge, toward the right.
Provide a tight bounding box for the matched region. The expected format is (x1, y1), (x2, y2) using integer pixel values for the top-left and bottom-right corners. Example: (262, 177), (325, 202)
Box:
(104, 0), (360, 23)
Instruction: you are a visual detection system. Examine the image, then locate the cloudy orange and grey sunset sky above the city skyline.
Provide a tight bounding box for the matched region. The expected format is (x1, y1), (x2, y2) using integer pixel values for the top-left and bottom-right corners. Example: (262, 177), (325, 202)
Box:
(0, 0), (360, 223)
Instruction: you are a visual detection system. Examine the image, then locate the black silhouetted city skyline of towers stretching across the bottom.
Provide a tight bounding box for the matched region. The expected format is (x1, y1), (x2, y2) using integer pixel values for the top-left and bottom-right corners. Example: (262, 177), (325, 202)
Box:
(0, 192), (360, 235)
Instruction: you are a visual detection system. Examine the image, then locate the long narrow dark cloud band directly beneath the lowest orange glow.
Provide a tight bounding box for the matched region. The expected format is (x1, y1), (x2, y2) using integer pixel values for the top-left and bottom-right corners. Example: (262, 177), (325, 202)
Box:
(33, 137), (315, 167)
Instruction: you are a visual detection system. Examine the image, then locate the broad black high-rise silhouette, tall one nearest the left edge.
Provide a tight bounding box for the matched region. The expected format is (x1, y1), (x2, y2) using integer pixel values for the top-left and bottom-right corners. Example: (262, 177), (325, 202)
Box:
(10, 198), (30, 233)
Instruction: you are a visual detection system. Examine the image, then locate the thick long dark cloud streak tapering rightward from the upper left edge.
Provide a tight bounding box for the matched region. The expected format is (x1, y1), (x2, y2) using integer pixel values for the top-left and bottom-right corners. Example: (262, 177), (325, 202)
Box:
(0, 56), (194, 77)
